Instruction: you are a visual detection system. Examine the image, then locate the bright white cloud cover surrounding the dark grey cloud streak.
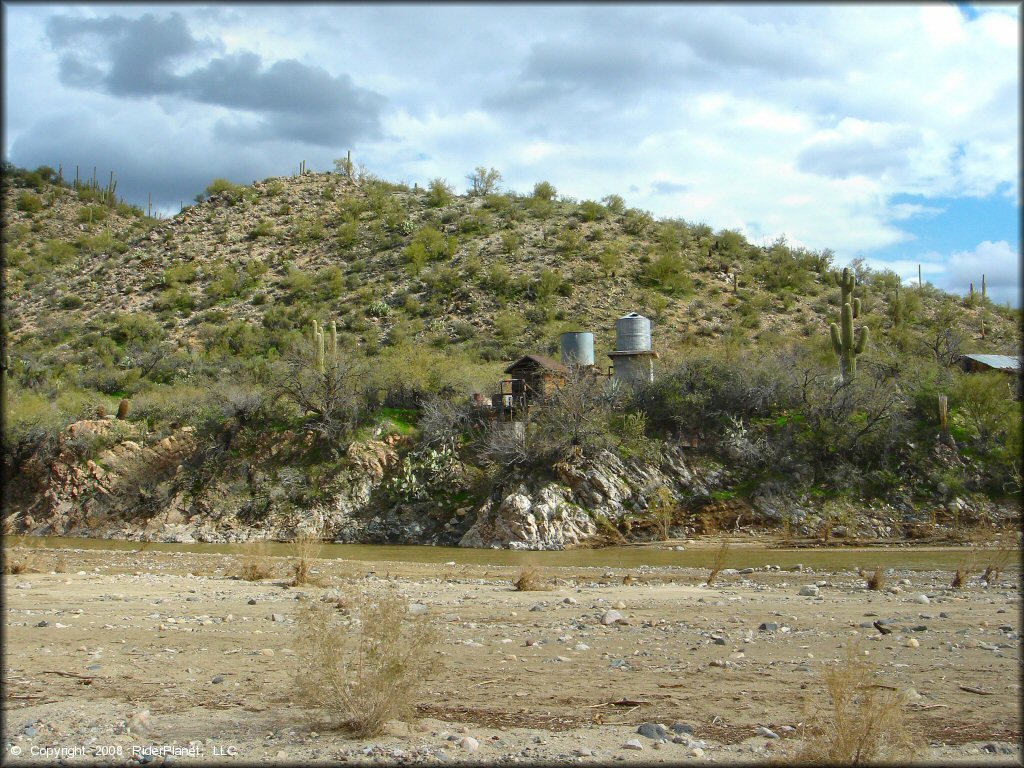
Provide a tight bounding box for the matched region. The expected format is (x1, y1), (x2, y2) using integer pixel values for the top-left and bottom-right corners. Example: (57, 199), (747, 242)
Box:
(4, 4), (1021, 286)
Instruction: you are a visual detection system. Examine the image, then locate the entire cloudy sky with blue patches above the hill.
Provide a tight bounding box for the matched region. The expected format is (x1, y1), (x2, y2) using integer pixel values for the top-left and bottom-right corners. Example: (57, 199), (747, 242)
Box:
(3, 2), (1021, 306)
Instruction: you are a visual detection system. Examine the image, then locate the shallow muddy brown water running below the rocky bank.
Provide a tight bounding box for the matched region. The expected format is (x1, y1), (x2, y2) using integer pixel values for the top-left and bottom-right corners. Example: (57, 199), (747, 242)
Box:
(12, 537), (1021, 570)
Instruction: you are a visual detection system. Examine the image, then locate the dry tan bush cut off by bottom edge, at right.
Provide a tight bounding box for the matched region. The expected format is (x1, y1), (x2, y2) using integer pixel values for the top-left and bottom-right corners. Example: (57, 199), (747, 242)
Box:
(796, 644), (919, 765)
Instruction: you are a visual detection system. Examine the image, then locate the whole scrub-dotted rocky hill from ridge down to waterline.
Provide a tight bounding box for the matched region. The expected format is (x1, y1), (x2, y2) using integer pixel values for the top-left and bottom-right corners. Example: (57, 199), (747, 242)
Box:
(3, 162), (1021, 546)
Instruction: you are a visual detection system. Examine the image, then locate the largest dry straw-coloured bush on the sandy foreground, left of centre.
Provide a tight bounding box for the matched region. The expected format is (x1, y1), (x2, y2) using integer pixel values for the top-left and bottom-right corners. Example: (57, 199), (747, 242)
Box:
(292, 593), (436, 738)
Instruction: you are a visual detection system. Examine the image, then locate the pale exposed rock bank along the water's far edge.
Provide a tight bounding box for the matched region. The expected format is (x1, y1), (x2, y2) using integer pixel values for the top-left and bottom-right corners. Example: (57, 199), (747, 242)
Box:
(9, 419), (707, 550)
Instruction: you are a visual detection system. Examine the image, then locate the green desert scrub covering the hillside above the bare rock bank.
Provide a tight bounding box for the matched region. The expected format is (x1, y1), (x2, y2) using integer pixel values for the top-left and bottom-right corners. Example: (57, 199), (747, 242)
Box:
(3, 166), (1021, 540)
